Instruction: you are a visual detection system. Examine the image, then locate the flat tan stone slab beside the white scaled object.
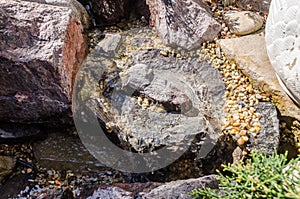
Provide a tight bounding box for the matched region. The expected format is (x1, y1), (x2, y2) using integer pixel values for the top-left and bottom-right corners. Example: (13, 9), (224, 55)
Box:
(220, 33), (300, 120)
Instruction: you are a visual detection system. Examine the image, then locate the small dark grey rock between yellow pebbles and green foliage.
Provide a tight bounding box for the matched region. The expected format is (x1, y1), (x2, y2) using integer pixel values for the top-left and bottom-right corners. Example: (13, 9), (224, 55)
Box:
(246, 102), (280, 155)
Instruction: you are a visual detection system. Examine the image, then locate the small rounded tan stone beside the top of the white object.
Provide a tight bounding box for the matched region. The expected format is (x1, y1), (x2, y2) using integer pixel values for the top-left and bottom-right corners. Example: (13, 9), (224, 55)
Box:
(224, 11), (264, 35)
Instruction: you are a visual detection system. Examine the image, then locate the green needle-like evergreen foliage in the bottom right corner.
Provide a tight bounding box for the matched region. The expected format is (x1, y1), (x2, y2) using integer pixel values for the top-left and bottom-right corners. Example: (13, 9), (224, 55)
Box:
(190, 150), (300, 199)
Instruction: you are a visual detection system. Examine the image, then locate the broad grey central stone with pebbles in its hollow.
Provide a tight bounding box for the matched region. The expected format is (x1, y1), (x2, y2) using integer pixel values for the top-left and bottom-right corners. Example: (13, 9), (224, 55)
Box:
(111, 50), (224, 154)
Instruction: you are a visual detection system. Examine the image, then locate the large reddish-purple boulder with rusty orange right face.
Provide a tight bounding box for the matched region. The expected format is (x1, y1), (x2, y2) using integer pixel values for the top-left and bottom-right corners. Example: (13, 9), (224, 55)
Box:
(0, 0), (87, 123)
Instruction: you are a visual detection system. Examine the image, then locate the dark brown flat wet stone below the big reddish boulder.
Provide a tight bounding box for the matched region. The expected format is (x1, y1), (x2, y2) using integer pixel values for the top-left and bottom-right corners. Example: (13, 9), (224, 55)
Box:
(33, 133), (103, 174)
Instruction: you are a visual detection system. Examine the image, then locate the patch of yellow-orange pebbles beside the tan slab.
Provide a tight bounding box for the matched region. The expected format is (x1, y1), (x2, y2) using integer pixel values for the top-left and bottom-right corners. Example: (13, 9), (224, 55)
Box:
(201, 38), (266, 147)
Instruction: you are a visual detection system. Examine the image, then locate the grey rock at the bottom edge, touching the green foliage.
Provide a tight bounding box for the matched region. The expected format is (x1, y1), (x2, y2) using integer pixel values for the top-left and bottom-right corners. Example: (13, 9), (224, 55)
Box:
(139, 175), (219, 199)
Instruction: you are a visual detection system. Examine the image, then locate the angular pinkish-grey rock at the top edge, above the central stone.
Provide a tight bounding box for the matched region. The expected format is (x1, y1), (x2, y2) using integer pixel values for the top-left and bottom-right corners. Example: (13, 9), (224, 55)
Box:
(147, 0), (221, 49)
